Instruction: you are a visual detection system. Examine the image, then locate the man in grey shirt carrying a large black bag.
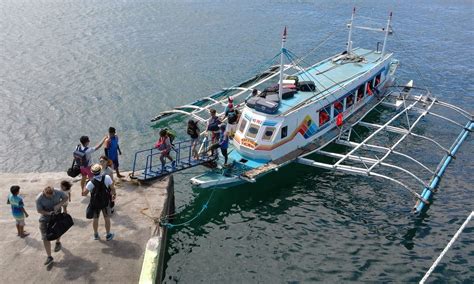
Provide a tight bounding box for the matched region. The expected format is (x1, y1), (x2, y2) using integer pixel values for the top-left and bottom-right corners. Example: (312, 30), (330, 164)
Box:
(36, 186), (68, 265)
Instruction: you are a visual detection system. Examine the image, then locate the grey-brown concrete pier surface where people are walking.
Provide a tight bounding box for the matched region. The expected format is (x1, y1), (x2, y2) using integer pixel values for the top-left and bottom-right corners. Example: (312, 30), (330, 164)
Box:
(0, 173), (173, 283)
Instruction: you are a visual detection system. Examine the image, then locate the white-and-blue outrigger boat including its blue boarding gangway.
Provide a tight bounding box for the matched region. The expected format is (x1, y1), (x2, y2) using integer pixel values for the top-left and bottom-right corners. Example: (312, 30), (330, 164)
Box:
(132, 9), (474, 213)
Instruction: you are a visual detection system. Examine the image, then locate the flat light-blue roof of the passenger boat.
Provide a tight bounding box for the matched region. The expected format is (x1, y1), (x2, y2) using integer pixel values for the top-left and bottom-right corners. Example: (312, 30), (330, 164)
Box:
(276, 48), (381, 115)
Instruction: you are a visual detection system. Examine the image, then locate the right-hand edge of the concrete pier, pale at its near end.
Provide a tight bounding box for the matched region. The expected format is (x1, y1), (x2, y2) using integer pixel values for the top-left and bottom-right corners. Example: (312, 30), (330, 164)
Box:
(139, 175), (175, 284)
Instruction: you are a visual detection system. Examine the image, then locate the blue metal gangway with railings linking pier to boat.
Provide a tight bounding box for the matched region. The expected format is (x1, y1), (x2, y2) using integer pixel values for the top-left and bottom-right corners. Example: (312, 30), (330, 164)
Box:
(130, 135), (218, 181)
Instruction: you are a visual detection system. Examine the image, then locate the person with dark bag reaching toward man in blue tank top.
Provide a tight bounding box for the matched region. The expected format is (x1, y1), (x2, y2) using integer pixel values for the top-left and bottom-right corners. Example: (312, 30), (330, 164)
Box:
(73, 136), (107, 190)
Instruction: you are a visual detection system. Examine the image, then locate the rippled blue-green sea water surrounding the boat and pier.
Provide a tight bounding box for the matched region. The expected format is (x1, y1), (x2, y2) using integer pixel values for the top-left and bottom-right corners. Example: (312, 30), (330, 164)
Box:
(0, 0), (474, 283)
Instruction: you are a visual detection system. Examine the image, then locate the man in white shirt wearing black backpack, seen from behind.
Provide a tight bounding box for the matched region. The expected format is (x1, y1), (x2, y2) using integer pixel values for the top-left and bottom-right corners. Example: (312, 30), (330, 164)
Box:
(82, 164), (116, 241)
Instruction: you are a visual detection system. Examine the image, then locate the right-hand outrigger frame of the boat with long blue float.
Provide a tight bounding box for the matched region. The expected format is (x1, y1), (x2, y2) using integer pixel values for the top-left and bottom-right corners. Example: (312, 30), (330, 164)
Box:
(296, 84), (474, 213)
